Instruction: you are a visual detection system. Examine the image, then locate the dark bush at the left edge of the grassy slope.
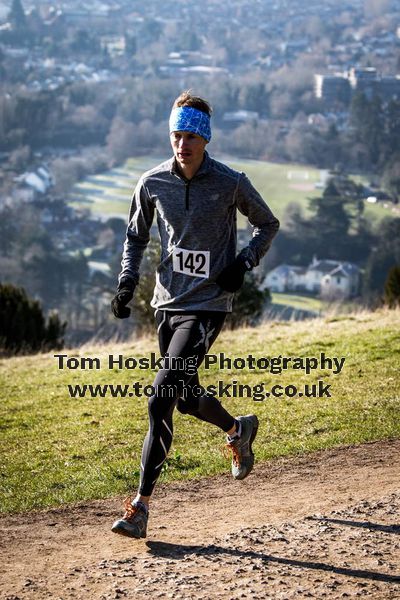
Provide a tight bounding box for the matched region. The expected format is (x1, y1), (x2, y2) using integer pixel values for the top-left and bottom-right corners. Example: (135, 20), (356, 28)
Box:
(0, 284), (67, 354)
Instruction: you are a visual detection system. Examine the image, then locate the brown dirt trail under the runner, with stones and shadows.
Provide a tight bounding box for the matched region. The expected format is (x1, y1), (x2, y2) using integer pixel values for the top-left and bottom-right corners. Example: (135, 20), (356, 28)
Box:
(0, 440), (400, 600)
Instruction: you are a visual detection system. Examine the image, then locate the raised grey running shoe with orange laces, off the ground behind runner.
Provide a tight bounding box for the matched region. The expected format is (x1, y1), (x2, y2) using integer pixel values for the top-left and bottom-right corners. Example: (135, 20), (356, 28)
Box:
(226, 415), (258, 479)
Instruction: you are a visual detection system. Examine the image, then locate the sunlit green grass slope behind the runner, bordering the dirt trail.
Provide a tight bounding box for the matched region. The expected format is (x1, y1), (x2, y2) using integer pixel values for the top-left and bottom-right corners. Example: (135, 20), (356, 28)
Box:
(0, 310), (400, 512)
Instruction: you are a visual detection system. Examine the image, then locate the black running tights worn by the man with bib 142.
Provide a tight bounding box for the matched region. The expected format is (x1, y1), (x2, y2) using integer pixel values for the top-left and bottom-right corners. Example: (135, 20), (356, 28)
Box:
(139, 311), (235, 496)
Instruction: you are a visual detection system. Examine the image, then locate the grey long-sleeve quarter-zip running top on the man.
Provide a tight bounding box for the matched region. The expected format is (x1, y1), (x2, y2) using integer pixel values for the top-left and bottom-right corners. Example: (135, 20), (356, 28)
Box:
(119, 152), (279, 312)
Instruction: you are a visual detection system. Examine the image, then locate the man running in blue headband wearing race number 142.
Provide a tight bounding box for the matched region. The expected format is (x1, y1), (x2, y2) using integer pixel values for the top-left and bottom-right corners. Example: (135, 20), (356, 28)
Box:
(111, 92), (279, 538)
